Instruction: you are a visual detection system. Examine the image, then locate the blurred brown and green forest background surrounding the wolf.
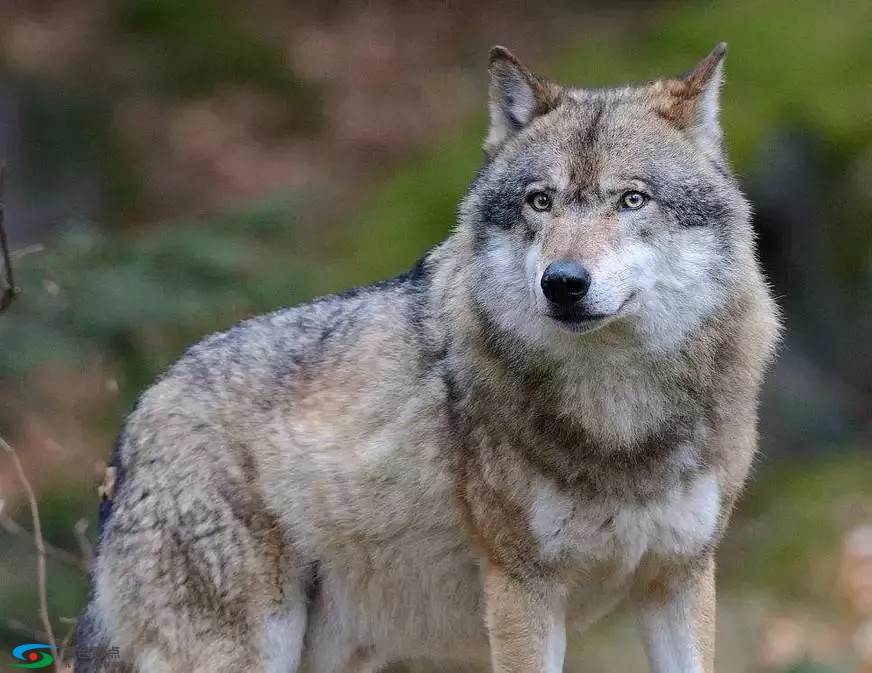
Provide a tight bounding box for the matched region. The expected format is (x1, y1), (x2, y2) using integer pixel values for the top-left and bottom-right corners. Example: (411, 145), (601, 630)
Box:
(0, 0), (872, 673)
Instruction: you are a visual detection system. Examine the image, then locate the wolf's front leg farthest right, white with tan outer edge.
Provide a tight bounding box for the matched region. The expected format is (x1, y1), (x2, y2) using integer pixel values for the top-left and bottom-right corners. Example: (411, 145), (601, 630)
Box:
(632, 556), (715, 673)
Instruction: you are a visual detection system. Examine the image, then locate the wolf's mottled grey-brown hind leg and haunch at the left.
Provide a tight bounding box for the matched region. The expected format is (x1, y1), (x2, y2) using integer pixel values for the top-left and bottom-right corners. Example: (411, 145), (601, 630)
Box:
(92, 433), (306, 673)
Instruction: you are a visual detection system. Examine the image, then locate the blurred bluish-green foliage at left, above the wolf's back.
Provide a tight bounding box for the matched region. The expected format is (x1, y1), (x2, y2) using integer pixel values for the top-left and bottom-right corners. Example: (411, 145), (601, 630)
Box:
(0, 194), (323, 403)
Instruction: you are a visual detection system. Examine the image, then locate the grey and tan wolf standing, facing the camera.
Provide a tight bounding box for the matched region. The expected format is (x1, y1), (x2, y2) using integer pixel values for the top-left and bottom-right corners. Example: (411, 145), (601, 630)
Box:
(80, 44), (779, 673)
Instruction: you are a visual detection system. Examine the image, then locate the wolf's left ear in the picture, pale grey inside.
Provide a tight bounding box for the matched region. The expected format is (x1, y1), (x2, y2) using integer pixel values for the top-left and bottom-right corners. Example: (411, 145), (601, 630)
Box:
(484, 47), (561, 155)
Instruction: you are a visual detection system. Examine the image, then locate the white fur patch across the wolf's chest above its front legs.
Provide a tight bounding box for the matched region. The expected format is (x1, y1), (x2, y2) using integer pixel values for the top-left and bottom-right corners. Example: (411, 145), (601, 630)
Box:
(530, 473), (720, 571)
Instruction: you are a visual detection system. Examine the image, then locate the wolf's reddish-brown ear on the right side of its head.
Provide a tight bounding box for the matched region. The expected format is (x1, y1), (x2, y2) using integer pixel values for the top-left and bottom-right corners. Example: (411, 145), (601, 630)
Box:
(654, 42), (727, 147)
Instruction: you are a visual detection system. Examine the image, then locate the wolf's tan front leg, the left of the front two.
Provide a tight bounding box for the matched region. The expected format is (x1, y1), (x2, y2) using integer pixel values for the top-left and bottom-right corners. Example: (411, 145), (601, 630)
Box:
(485, 567), (566, 673)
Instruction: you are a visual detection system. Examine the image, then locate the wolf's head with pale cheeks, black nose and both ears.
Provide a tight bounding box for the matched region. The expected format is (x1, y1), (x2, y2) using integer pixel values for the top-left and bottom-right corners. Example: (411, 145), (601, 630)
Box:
(460, 45), (756, 349)
